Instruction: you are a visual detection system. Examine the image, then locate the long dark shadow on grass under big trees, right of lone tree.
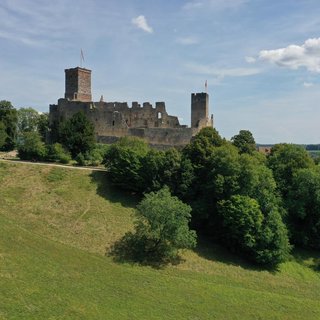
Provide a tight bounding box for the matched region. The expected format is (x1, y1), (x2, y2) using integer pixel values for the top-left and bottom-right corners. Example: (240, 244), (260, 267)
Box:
(194, 235), (277, 273)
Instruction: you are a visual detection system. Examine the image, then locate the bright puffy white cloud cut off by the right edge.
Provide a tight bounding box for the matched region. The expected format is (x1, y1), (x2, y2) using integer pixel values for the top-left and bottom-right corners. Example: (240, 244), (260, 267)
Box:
(259, 38), (320, 72)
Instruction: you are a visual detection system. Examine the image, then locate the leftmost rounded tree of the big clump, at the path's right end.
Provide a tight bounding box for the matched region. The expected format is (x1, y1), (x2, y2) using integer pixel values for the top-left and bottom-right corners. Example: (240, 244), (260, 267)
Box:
(104, 137), (150, 192)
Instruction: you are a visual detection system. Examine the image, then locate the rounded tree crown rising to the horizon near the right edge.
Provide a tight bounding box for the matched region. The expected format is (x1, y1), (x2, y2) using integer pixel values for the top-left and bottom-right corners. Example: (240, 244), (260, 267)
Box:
(268, 143), (314, 198)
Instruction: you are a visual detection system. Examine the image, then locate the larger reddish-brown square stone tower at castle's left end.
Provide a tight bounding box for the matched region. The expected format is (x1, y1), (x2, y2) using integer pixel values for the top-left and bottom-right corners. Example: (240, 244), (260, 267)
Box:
(64, 67), (92, 102)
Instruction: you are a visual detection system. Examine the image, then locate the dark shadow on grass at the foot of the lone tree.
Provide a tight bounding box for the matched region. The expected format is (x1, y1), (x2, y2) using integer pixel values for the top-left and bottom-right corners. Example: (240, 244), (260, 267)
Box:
(106, 232), (183, 269)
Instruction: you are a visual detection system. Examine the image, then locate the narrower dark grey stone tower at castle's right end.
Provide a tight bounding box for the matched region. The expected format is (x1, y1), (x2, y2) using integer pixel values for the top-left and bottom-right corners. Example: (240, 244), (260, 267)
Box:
(191, 92), (213, 130)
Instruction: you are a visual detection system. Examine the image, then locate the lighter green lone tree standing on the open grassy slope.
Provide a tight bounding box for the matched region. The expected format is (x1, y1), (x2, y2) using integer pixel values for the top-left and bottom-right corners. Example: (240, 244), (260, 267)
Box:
(131, 188), (196, 260)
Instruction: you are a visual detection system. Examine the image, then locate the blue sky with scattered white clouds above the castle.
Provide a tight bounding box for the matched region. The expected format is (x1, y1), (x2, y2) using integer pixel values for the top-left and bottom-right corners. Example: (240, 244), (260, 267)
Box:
(0, 0), (320, 143)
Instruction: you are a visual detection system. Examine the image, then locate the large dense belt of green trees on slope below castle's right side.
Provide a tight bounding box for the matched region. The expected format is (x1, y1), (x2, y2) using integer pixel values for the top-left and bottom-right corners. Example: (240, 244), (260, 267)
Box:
(105, 128), (320, 266)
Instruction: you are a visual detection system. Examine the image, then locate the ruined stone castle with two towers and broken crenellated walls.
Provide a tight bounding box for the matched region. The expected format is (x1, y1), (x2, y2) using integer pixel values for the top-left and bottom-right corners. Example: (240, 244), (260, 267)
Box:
(49, 67), (213, 148)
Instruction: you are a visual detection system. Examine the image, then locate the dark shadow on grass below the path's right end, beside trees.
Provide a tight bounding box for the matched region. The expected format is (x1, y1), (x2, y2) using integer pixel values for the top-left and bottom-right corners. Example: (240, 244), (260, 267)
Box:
(90, 171), (141, 208)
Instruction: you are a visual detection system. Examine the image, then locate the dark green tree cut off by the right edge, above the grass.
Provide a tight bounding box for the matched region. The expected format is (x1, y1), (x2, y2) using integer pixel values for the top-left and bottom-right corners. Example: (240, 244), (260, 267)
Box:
(286, 167), (320, 249)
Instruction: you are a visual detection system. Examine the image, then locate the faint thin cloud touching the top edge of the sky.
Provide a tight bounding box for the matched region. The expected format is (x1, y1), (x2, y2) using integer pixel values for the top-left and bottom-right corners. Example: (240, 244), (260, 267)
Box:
(182, 0), (250, 10)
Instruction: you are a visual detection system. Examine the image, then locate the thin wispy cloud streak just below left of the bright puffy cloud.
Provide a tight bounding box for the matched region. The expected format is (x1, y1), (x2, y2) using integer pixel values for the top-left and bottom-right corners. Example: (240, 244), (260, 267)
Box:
(187, 64), (260, 78)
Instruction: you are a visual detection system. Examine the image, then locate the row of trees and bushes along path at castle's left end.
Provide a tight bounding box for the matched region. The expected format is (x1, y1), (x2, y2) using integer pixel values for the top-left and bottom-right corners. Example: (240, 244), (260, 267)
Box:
(0, 101), (101, 164)
